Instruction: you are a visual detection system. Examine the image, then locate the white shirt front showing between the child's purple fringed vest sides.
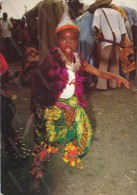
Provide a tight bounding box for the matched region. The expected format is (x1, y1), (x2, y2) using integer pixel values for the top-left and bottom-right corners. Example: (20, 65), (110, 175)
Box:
(60, 66), (75, 99)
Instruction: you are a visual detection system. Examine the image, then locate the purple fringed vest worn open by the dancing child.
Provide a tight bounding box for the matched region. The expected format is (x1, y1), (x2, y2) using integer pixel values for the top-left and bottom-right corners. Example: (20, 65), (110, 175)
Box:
(34, 48), (86, 107)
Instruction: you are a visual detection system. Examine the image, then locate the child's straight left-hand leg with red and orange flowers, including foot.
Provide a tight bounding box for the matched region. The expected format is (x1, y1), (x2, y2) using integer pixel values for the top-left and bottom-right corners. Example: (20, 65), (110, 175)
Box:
(30, 110), (58, 193)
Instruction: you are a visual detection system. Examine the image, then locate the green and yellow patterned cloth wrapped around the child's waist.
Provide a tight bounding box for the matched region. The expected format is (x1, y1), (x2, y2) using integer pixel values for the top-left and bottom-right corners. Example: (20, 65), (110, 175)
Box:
(35, 95), (92, 153)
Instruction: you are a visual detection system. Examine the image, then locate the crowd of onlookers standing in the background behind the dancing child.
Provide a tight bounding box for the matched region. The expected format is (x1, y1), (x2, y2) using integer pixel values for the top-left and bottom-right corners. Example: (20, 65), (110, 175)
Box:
(0, 0), (137, 85)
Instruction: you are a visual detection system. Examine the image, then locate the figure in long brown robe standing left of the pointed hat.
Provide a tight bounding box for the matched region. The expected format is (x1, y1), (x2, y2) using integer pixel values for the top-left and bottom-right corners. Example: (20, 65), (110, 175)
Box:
(25, 0), (63, 61)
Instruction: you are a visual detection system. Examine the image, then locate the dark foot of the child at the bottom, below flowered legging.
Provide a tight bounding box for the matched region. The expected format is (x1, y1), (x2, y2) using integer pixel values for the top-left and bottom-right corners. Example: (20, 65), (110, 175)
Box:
(30, 178), (42, 194)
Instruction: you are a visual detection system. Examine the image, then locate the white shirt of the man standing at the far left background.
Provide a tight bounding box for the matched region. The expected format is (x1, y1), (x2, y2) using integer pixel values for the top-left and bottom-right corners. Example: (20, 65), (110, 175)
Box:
(0, 19), (13, 38)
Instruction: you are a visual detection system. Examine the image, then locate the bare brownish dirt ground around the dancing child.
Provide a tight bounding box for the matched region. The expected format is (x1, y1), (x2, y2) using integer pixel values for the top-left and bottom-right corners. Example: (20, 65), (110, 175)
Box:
(1, 63), (137, 195)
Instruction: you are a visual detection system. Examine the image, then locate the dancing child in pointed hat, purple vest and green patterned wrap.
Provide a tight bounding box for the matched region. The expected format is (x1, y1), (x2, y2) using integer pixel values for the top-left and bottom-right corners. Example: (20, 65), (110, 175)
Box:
(30, 4), (129, 193)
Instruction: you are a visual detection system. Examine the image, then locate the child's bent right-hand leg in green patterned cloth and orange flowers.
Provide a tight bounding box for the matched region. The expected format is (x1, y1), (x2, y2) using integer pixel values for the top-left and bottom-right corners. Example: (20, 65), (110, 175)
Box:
(63, 106), (92, 166)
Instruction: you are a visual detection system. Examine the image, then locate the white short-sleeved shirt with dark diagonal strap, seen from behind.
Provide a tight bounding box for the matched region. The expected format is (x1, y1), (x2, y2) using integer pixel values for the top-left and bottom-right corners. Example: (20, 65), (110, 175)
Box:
(92, 8), (126, 48)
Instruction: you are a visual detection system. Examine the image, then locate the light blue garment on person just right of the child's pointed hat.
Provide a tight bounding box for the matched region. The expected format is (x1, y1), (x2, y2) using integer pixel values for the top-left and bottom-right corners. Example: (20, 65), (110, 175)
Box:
(75, 11), (94, 66)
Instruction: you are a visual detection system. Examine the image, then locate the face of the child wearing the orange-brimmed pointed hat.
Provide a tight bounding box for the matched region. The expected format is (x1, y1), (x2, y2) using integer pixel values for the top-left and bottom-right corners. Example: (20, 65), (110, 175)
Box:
(57, 29), (79, 57)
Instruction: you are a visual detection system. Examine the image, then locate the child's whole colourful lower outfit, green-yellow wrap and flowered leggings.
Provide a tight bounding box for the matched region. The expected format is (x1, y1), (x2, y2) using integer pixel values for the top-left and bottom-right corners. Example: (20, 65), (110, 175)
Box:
(31, 95), (92, 178)
